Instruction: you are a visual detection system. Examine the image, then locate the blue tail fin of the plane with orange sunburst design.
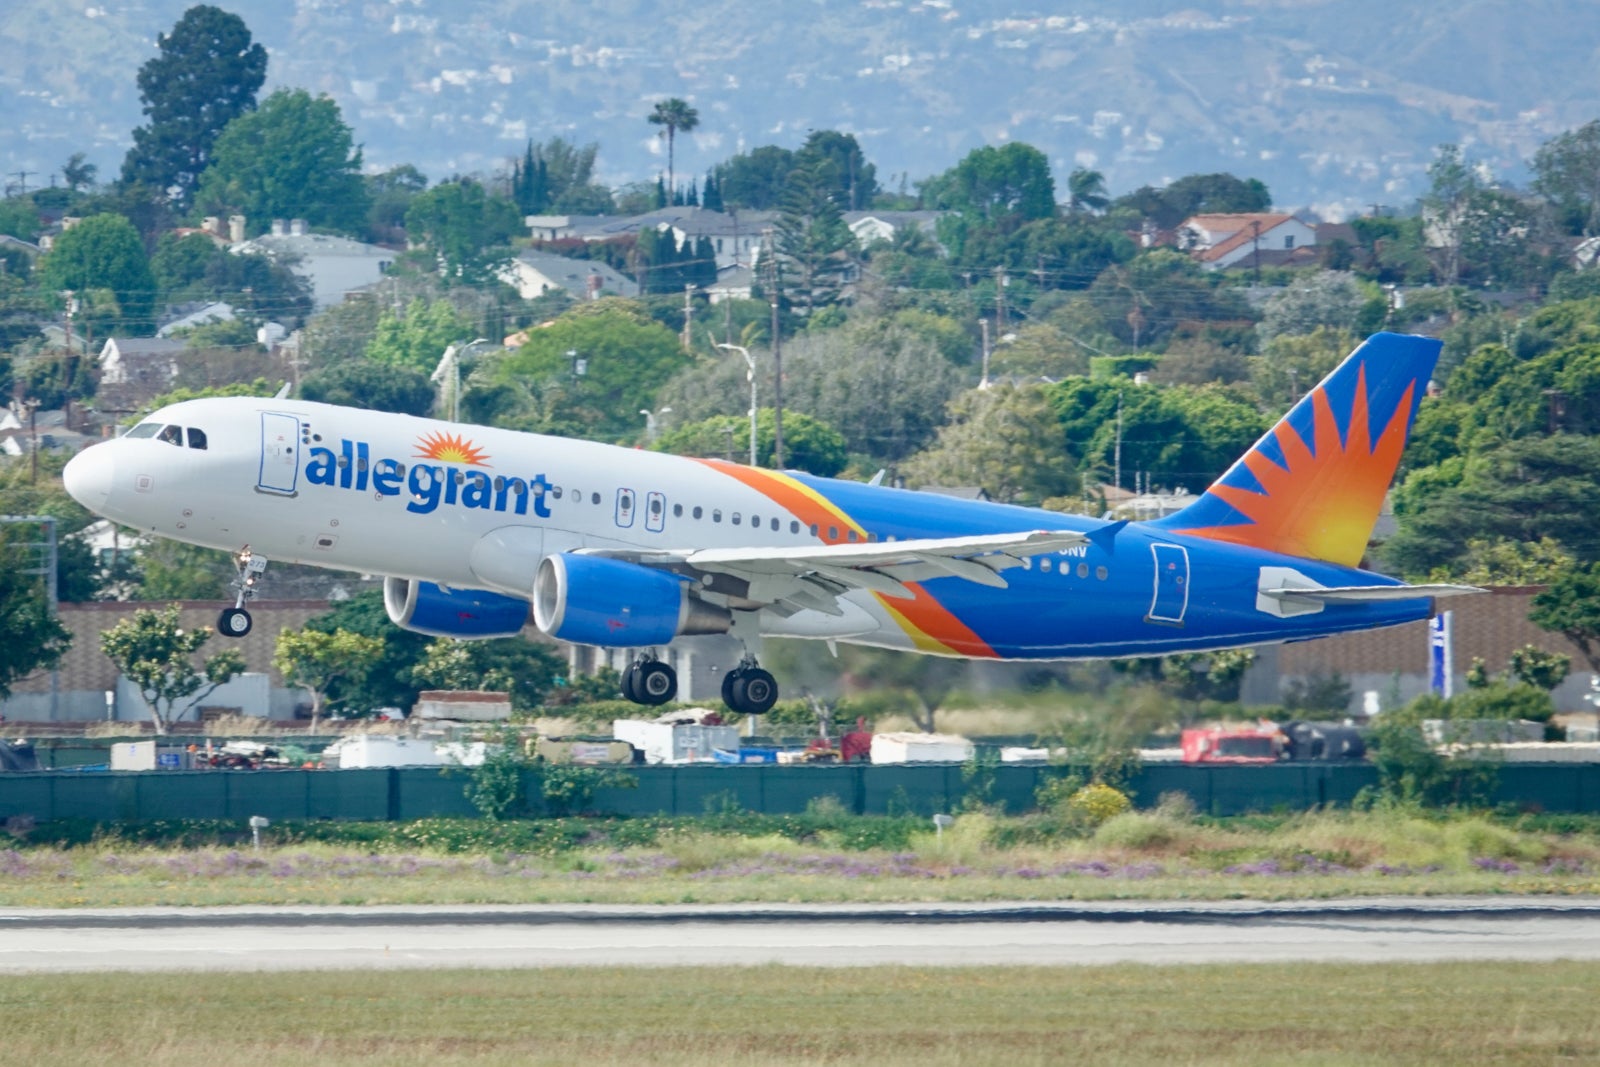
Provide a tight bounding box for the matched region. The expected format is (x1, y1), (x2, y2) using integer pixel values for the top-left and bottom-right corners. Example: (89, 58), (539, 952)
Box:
(1154, 333), (1442, 566)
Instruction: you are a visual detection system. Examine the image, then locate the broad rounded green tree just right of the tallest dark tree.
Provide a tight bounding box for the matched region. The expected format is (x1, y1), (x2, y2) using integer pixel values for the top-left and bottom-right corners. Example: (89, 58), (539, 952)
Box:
(195, 90), (366, 234)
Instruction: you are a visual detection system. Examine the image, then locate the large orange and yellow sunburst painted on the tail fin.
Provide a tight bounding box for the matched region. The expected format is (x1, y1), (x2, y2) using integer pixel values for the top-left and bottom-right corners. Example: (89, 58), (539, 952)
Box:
(1184, 365), (1416, 566)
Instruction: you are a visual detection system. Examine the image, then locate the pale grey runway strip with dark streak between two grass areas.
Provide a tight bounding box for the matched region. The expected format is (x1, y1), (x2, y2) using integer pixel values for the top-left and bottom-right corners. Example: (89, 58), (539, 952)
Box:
(0, 897), (1600, 974)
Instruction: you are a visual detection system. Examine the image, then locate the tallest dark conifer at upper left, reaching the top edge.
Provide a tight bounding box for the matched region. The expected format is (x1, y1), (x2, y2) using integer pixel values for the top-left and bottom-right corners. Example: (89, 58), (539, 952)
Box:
(122, 5), (267, 205)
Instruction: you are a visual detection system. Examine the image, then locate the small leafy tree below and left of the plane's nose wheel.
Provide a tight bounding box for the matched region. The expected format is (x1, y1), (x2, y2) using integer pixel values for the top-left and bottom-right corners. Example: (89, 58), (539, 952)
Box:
(101, 605), (245, 734)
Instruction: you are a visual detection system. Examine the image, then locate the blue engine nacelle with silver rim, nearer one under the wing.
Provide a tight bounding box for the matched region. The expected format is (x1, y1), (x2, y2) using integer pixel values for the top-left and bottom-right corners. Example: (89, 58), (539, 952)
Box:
(533, 553), (733, 648)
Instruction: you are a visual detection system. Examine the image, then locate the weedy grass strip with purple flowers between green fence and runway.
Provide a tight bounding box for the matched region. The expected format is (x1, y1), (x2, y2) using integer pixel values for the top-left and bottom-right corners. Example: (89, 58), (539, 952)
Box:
(0, 813), (1600, 907)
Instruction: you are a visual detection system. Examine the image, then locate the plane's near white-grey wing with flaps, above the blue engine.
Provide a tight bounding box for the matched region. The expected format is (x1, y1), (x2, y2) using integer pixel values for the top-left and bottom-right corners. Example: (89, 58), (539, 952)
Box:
(584, 523), (1100, 616)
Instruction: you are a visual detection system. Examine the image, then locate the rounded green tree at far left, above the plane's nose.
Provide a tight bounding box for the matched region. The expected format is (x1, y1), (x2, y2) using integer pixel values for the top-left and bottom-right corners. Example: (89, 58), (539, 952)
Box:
(38, 214), (155, 336)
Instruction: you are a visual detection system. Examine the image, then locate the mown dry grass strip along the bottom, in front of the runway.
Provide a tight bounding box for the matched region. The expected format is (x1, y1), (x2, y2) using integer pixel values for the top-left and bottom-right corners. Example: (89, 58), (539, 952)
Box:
(0, 963), (1600, 1067)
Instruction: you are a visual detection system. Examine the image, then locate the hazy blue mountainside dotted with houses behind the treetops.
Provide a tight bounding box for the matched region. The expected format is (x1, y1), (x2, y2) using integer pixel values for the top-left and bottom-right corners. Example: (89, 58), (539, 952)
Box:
(0, 0), (1600, 211)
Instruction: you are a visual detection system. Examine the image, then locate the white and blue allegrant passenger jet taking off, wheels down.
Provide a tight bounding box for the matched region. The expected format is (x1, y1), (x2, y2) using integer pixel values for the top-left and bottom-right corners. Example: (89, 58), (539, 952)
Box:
(64, 333), (1477, 713)
